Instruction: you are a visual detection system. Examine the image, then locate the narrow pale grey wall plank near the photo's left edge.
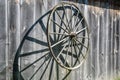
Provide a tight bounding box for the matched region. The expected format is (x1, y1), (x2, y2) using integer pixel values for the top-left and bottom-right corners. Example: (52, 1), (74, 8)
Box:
(5, 0), (12, 80)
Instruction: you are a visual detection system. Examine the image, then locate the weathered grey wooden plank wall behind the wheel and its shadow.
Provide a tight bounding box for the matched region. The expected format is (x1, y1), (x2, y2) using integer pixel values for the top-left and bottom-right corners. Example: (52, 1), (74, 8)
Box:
(0, 0), (120, 80)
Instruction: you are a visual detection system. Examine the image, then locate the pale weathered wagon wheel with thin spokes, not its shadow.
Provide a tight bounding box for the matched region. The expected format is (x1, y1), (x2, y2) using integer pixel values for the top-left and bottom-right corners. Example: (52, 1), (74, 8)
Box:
(47, 2), (89, 70)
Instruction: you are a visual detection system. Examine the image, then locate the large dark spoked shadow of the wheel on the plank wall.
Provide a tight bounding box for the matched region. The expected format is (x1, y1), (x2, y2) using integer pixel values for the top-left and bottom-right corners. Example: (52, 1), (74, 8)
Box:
(13, 10), (71, 80)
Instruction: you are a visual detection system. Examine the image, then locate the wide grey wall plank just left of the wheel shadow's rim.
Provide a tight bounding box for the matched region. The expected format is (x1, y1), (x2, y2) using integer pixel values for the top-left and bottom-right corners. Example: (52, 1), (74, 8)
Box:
(7, 0), (20, 80)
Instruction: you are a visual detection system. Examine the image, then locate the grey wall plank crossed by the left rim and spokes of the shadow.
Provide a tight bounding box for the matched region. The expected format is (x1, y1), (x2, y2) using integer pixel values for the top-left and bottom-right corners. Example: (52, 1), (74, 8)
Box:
(20, 0), (36, 79)
